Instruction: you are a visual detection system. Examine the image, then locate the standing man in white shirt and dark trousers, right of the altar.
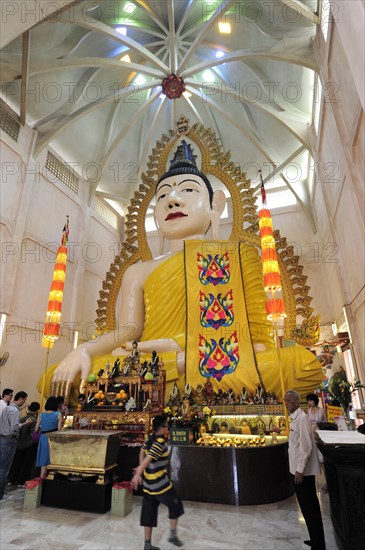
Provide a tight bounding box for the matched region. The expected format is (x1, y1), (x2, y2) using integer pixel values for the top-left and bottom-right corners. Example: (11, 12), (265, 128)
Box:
(284, 390), (326, 550)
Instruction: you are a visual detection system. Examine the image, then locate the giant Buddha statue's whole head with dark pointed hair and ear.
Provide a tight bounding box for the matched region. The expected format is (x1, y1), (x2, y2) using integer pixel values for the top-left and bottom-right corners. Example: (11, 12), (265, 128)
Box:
(155, 140), (226, 245)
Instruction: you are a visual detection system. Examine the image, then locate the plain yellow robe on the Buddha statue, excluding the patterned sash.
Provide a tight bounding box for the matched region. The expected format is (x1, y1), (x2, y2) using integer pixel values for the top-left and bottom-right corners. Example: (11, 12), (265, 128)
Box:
(39, 243), (323, 400)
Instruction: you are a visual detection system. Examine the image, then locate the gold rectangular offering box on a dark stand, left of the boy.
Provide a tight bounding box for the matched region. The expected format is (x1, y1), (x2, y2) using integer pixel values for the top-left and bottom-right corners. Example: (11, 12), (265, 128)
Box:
(47, 430), (121, 483)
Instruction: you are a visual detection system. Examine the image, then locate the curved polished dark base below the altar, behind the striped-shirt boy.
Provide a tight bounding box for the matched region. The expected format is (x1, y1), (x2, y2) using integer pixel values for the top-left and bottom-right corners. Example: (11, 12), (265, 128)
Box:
(170, 443), (294, 505)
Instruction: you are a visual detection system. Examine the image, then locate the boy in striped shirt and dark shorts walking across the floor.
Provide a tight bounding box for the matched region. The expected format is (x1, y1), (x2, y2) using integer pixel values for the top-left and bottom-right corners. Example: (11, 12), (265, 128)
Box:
(131, 415), (184, 550)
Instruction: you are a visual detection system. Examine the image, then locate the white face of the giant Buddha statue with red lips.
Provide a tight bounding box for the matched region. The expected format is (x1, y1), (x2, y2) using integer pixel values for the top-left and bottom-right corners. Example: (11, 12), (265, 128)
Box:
(155, 174), (211, 239)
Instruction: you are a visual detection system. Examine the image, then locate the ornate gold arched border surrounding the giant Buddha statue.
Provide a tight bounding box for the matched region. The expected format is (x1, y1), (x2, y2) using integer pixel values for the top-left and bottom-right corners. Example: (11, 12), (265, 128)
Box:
(95, 124), (319, 345)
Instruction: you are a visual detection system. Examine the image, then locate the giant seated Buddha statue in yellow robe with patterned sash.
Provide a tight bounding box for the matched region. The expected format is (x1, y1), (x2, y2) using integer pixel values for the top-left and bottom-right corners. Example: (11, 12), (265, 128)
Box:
(48, 127), (323, 406)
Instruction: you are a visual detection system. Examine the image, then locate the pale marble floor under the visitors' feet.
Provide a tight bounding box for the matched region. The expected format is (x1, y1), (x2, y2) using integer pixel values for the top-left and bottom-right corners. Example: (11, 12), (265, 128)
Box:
(0, 488), (337, 550)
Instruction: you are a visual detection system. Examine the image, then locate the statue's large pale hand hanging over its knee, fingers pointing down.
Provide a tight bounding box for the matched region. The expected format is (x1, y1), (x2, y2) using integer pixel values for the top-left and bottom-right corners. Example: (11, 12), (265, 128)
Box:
(51, 343), (91, 403)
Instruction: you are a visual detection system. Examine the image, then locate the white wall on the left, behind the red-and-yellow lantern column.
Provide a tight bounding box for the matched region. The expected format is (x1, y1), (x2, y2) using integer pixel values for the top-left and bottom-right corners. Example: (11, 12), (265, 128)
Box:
(0, 123), (120, 401)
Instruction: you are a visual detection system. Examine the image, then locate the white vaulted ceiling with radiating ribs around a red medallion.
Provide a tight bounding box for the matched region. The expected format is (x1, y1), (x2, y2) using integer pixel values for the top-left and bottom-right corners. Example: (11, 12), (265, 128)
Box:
(1, 0), (318, 226)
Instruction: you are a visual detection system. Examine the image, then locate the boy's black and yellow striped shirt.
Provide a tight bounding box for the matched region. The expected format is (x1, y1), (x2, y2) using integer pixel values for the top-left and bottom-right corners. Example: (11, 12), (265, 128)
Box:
(142, 436), (172, 495)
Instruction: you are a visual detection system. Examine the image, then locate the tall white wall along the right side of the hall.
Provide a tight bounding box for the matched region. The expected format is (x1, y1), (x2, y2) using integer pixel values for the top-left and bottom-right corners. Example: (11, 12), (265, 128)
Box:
(312, 0), (365, 381)
